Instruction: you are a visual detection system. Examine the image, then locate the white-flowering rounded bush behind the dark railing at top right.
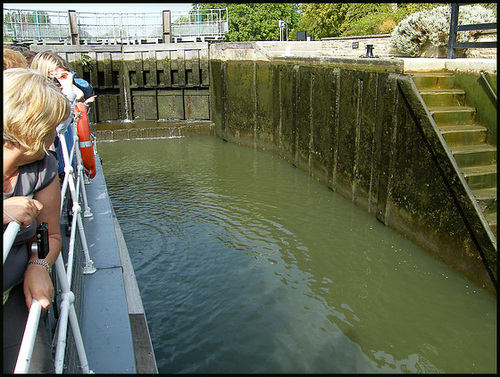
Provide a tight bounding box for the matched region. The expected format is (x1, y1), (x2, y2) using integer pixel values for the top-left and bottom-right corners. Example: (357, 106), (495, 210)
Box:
(391, 5), (496, 57)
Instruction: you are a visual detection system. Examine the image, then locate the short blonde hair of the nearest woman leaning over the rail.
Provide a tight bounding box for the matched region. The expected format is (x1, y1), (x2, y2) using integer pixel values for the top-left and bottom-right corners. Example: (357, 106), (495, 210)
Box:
(3, 68), (71, 155)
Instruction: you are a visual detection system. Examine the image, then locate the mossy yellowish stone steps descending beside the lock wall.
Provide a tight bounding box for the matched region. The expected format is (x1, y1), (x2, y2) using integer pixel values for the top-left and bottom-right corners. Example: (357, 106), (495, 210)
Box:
(411, 73), (497, 238)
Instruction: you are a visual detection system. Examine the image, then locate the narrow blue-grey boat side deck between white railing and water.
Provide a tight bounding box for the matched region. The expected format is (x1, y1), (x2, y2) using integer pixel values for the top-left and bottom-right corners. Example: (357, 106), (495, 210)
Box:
(63, 151), (158, 374)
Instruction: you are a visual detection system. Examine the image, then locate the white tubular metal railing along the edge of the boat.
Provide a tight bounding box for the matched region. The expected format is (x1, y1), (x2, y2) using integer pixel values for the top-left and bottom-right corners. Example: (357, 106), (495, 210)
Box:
(3, 97), (96, 374)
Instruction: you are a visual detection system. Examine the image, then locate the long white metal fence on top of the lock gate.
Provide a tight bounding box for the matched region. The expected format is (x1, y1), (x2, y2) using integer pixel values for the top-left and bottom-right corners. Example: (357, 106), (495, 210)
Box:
(3, 8), (229, 44)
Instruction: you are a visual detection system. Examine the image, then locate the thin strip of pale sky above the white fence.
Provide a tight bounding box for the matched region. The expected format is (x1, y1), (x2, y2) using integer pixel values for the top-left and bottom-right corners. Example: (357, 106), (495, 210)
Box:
(3, 2), (192, 13)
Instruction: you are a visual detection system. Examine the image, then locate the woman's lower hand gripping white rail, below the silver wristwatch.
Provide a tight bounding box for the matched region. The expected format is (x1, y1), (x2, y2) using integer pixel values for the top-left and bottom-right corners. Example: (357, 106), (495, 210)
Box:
(23, 264), (54, 311)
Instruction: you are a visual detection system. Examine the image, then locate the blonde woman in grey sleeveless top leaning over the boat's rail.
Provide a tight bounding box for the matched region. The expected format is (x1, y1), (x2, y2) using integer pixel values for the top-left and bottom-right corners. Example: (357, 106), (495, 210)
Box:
(3, 68), (70, 373)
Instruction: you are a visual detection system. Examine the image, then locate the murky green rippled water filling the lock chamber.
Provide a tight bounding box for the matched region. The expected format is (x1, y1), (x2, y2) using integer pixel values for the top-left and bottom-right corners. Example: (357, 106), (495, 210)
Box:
(98, 136), (497, 373)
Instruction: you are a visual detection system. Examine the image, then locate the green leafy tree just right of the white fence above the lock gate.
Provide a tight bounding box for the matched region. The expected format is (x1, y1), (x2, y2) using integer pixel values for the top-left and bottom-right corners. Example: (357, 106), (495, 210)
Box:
(193, 3), (300, 42)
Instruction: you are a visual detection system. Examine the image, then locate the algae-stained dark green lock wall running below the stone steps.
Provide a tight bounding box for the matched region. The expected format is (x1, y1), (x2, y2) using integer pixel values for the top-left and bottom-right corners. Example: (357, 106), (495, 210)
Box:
(211, 58), (496, 290)
